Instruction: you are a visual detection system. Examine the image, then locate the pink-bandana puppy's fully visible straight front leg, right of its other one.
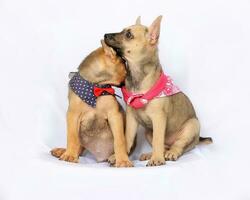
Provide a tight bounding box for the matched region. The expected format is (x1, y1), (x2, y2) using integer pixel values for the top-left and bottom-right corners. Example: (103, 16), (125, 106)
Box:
(147, 112), (167, 166)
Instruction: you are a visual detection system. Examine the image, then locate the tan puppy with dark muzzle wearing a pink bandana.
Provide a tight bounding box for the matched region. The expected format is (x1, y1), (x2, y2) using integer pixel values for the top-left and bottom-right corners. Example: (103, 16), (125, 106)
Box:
(104, 16), (211, 166)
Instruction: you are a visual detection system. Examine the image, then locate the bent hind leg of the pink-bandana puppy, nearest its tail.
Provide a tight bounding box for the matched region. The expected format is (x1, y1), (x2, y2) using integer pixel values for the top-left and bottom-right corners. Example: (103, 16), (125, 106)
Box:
(165, 118), (200, 161)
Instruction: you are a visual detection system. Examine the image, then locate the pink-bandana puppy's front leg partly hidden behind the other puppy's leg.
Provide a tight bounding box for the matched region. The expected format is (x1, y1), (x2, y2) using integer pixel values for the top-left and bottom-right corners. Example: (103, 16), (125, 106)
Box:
(125, 107), (138, 154)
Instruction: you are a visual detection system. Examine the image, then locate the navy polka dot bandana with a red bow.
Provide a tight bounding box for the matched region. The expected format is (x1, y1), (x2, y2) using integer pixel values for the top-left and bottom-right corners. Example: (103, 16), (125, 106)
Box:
(69, 72), (115, 107)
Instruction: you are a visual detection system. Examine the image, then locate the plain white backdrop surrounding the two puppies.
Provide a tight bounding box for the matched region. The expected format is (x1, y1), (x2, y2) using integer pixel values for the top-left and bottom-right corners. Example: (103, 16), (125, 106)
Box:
(0, 0), (250, 200)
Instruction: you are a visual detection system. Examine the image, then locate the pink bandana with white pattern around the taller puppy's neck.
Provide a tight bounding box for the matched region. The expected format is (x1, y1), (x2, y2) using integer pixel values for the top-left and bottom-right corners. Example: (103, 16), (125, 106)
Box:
(122, 73), (180, 109)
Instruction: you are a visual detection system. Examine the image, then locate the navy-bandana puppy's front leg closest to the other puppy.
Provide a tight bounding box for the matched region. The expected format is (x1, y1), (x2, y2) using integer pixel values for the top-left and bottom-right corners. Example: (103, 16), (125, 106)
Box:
(108, 111), (133, 167)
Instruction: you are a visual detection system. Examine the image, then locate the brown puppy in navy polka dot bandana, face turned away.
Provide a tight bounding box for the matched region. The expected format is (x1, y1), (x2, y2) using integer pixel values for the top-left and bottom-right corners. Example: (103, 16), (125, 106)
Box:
(51, 41), (133, 167)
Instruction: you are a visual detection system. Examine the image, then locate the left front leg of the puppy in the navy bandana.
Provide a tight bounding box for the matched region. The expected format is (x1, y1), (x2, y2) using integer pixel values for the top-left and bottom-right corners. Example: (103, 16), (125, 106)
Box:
(59, 109), (82, 162)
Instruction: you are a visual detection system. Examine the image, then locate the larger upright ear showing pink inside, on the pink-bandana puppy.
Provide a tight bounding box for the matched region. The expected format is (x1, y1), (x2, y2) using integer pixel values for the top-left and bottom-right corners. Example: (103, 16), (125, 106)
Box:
(149, 15), (162, 45)
